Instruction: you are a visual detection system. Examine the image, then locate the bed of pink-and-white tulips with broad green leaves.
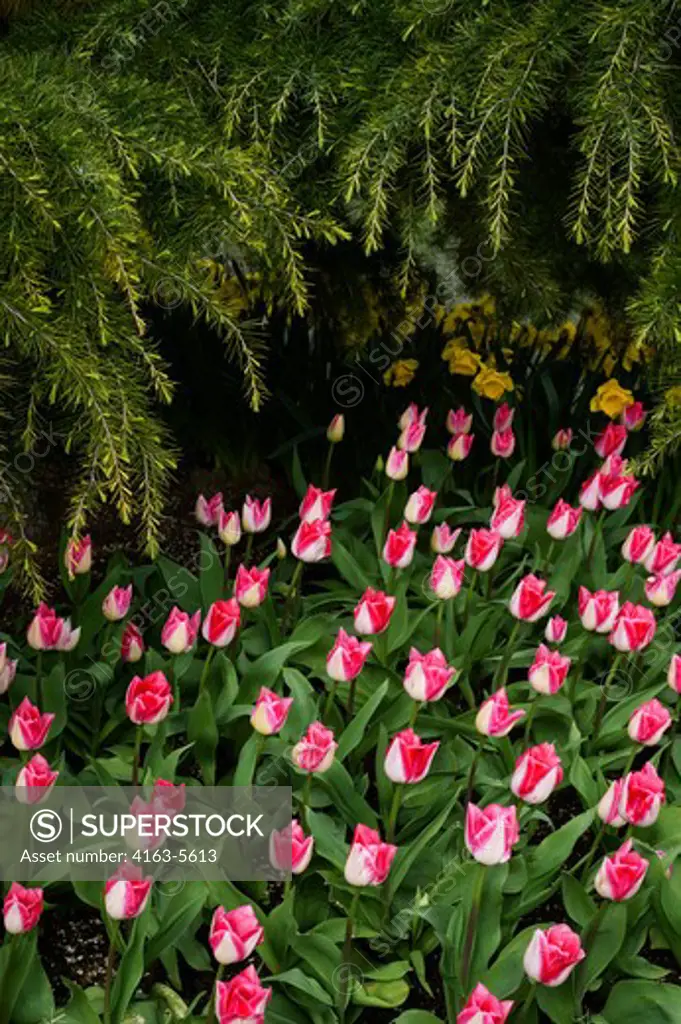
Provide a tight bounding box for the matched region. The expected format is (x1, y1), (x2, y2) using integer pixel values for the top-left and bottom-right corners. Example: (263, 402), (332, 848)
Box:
(0, 407), (681, 1024)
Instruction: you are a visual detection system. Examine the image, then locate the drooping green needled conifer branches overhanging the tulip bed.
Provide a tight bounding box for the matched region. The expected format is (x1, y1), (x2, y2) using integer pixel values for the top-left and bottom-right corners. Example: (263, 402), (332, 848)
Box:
(0, 0), (681, 589)
